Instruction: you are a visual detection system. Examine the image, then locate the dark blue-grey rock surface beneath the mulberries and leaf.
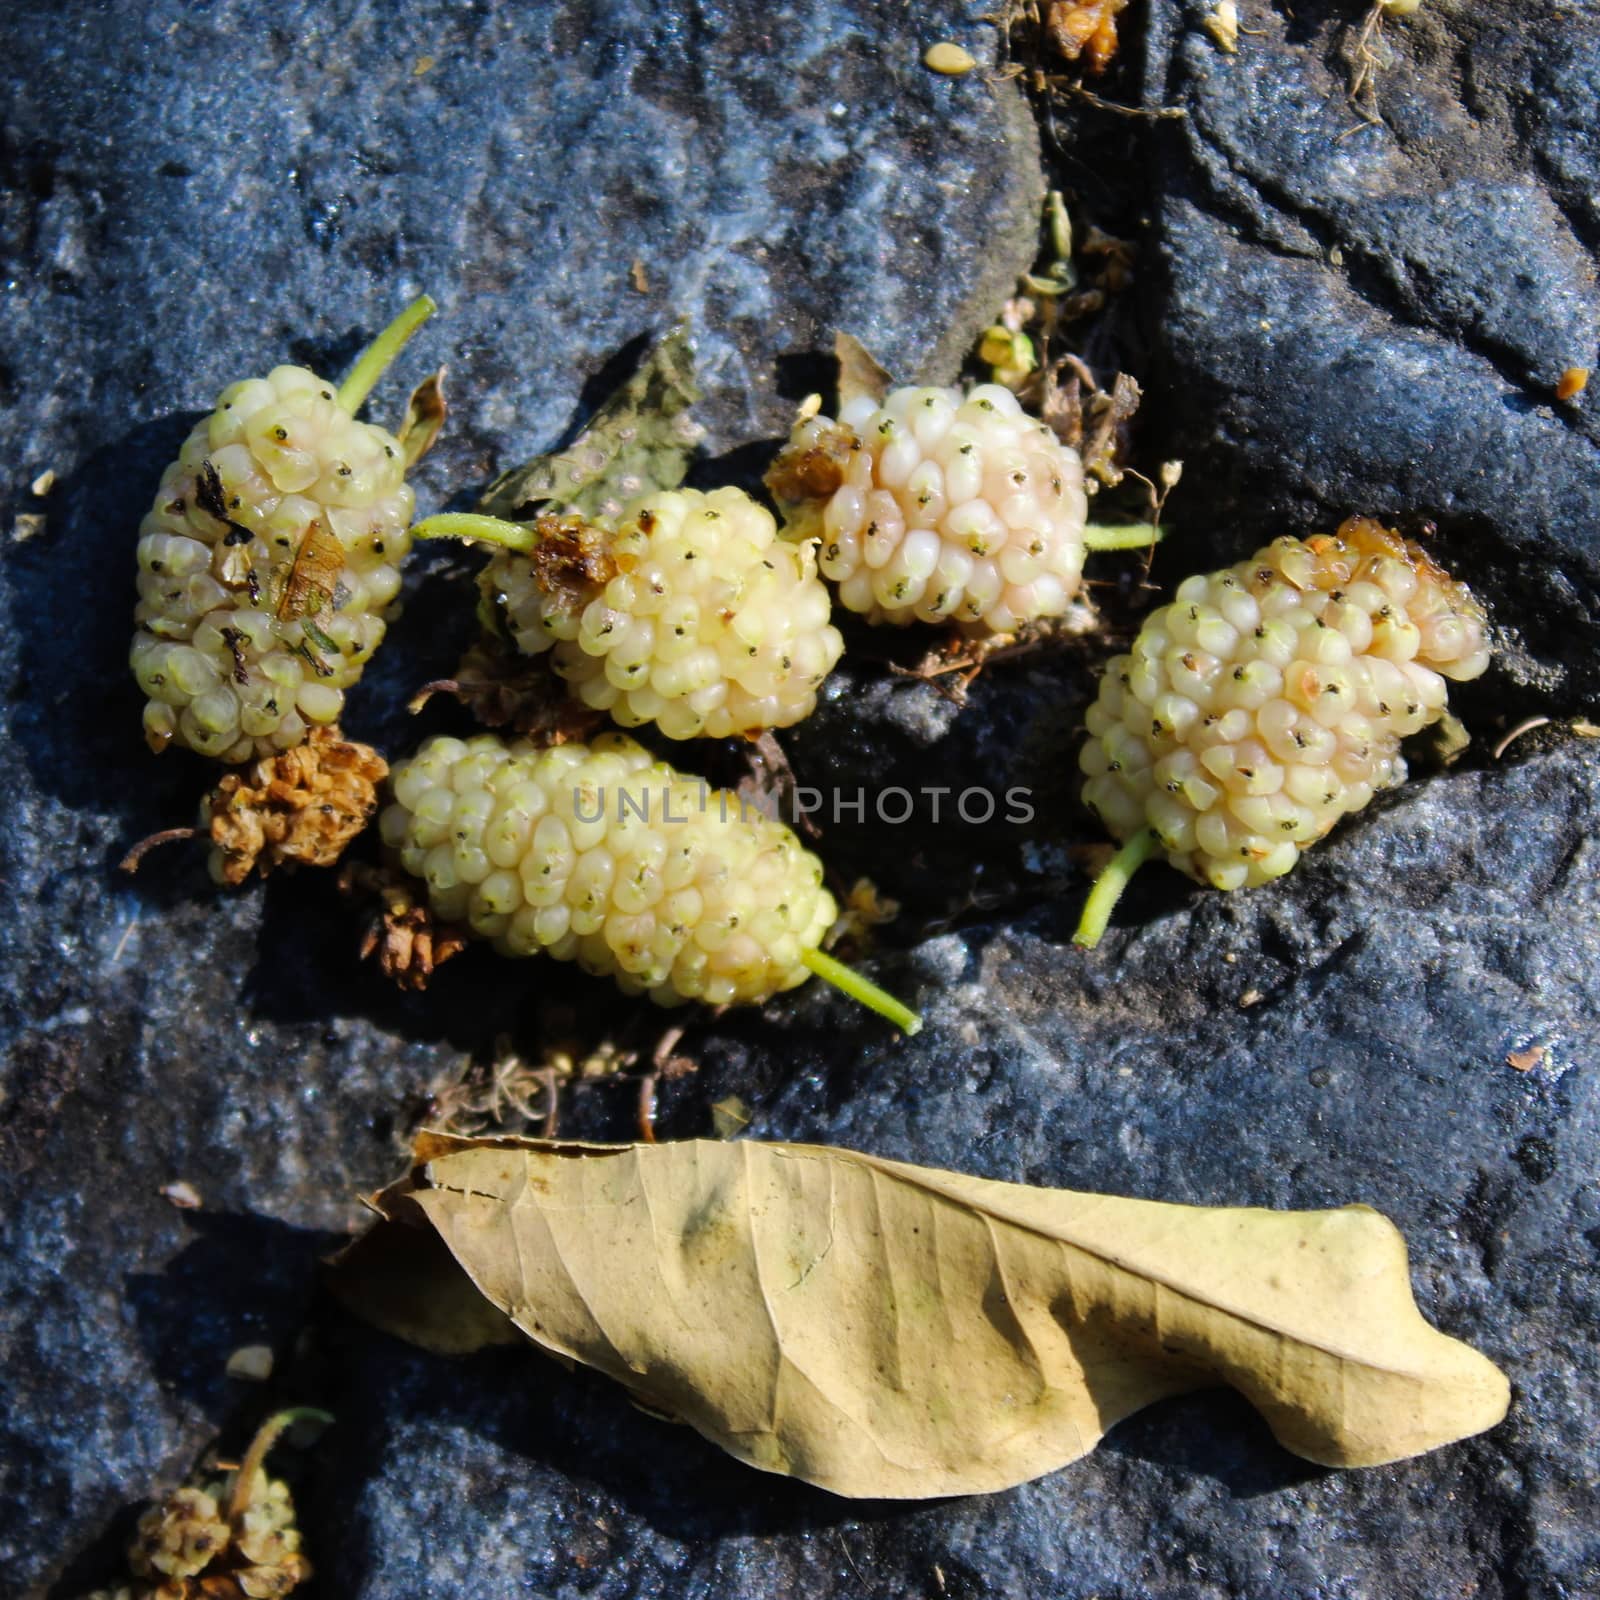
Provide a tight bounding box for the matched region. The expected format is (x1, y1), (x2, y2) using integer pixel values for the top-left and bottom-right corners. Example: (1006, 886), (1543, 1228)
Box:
(0, 0), (1600, 1600)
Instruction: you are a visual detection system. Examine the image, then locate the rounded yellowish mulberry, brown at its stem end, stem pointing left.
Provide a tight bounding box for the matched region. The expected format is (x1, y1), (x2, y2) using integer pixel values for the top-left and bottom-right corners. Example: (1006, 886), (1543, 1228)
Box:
(414, 488), (845, 739)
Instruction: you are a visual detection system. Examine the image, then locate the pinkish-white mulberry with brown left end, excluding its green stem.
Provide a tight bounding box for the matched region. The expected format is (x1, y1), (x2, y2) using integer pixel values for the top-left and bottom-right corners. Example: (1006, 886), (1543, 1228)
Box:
(766, 384), (1088, 634)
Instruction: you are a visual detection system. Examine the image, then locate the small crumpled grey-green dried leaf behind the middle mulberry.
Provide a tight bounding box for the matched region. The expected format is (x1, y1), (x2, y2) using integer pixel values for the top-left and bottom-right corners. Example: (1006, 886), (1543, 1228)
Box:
(478, 323), (702, 522)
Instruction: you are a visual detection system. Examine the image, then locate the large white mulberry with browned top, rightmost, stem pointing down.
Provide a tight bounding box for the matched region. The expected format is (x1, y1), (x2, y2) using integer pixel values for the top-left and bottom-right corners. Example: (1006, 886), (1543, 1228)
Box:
(1078, 517), (1490, 944)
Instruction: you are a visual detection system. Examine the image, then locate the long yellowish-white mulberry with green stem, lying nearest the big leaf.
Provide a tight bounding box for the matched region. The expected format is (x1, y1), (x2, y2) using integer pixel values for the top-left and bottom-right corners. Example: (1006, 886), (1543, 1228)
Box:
(381, 733), (915, 1029)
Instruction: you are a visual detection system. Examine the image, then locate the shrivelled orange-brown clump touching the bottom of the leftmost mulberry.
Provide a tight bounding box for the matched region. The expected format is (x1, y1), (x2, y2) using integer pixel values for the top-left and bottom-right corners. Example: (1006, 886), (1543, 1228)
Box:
(203, 728), (389, 883)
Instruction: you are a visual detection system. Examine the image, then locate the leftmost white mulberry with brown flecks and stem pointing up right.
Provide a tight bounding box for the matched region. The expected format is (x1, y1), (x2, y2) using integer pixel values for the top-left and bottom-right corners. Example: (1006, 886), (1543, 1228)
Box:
(131, 296), (434, 762)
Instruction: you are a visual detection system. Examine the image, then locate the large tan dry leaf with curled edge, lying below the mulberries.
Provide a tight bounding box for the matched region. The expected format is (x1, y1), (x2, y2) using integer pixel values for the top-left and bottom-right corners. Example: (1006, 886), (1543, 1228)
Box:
(344, 1134), (1509, 1498)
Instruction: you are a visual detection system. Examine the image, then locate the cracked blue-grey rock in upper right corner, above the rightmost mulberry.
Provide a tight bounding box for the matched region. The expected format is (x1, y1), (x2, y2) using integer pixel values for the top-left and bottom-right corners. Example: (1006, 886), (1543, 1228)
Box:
(1146, 0), (1600, 710)
